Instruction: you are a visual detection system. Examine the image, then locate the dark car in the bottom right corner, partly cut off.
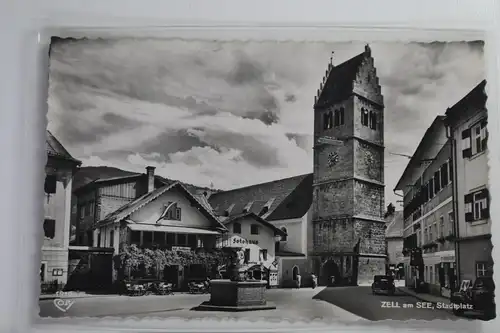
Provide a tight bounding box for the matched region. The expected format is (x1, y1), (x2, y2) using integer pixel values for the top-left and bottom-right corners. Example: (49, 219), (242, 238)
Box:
(450, 277), (496, 318)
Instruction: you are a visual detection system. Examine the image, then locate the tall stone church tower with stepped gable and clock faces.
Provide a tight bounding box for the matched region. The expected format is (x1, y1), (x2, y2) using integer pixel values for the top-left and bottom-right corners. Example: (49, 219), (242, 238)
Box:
(310, 45), (386, 285)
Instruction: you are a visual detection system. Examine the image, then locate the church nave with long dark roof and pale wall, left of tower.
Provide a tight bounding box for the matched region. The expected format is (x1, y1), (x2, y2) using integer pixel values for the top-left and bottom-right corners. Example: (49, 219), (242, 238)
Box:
(208, 174), (313, 287)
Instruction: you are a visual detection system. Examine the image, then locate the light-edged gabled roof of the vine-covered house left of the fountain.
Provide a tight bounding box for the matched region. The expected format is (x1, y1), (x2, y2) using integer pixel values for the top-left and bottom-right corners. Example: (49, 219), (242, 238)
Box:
(99, 182), (227, 230)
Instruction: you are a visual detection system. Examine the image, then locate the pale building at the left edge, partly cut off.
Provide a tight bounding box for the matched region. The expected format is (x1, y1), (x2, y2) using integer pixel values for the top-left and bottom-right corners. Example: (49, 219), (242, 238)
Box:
(40, 131), (81, 284)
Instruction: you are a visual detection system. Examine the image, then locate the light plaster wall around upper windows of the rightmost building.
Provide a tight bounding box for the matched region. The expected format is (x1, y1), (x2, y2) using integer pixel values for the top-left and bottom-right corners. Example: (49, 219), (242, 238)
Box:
(454, 111), (493, 238)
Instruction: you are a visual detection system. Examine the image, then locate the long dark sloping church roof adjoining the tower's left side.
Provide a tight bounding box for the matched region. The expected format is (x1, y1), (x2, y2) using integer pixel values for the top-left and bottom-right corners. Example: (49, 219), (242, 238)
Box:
(208, 174), (313, 221)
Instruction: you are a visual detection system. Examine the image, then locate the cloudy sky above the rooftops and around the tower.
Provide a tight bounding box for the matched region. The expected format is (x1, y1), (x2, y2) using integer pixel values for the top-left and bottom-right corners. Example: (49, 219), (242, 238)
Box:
(48, 39), (485, 203)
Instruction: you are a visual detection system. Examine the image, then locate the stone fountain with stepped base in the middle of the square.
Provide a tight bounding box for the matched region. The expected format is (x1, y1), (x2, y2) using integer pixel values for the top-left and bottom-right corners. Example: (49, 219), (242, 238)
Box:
(196, 249), (276, 312)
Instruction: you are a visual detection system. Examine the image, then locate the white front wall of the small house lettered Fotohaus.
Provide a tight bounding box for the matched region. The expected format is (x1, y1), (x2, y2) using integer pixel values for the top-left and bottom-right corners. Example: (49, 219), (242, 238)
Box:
(217, 217), (275, 266)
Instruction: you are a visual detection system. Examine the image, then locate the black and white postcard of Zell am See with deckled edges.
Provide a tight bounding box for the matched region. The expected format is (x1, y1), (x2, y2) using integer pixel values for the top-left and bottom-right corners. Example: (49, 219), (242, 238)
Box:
(39, 37), (496, 322)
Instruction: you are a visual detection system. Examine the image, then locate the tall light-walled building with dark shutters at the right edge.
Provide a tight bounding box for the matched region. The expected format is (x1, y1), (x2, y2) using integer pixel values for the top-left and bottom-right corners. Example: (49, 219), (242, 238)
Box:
(446, 81), (493, 282)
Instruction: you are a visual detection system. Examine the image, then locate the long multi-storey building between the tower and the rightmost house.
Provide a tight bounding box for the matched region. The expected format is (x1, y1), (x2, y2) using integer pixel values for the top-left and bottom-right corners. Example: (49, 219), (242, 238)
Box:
(395, 116), (456, 297)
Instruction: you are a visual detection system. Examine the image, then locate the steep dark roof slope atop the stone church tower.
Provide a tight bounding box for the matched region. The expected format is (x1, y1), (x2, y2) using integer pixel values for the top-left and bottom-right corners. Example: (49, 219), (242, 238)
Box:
(314, 44), (371, 107)
